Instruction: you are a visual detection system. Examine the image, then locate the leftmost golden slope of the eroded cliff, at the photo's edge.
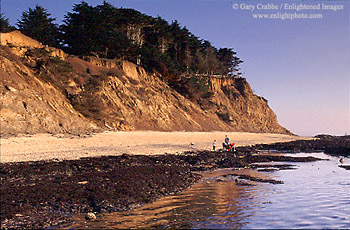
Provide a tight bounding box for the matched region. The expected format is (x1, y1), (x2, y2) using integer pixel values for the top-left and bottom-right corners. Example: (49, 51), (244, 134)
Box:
(0, 47), (98, 136)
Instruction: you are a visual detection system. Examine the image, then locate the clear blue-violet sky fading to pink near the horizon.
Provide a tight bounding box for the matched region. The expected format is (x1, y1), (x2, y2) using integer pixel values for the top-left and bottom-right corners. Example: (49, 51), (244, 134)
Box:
(1, 0), (350, 136)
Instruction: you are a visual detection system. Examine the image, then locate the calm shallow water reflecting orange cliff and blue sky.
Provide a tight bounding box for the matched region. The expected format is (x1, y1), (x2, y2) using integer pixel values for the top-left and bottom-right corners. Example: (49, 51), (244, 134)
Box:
(70, 153), (350, 229)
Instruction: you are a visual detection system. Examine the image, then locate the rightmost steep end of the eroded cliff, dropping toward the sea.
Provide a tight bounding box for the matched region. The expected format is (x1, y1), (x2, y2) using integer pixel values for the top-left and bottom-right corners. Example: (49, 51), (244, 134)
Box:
(209, 78), (290, 133)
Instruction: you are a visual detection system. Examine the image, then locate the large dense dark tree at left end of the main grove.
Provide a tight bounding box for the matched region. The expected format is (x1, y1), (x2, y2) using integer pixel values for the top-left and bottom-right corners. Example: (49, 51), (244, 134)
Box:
(61, 2), (139, 61)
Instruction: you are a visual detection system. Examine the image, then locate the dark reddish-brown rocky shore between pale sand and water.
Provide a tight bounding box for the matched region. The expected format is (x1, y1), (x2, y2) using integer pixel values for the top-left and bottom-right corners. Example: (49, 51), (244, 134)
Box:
(0, 147), (320, 228)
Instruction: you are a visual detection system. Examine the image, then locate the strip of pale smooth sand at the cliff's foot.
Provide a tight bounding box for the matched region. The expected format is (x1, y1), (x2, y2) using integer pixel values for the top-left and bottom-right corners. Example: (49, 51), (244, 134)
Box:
(0, 131), (310, 163)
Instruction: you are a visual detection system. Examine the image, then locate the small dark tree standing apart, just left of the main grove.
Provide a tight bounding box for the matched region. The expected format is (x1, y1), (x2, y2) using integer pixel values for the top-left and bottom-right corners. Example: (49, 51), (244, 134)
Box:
(17, 5), (59, 47)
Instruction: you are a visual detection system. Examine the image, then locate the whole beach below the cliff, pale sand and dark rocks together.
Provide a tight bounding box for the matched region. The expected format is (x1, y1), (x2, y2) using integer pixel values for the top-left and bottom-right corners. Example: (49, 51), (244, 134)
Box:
(0, 132), (349, 228)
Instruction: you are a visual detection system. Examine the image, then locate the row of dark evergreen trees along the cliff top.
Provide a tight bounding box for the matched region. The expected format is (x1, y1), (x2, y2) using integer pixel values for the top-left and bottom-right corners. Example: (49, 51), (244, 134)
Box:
(1, 2), (242, 77)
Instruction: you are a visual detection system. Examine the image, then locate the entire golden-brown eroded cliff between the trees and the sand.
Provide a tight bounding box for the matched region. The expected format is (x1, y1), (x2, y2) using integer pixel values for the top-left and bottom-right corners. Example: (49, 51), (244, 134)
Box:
(0, 30), (289, 135)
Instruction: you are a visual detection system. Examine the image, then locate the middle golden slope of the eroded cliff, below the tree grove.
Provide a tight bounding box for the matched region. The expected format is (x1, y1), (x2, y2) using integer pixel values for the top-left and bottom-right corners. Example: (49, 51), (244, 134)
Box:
(69, 61), (230, 131)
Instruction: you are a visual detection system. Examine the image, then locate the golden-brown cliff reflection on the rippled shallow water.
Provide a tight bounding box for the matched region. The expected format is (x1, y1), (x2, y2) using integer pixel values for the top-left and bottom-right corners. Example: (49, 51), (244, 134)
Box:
(70, 169), (266, 228)
